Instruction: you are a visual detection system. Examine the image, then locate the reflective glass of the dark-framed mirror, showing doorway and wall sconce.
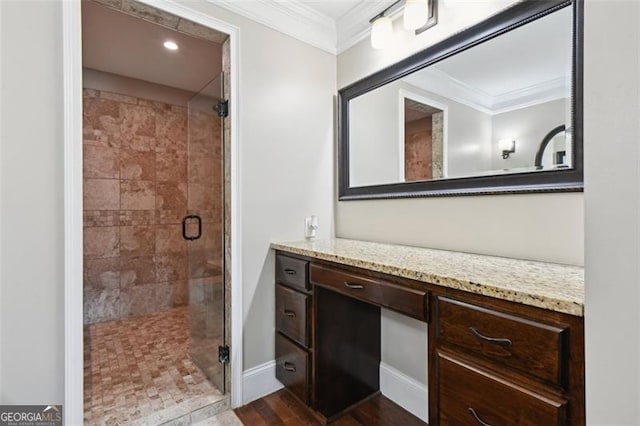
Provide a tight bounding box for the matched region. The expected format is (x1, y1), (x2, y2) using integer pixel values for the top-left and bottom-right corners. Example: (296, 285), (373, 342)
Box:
(348, 7), (574, 187)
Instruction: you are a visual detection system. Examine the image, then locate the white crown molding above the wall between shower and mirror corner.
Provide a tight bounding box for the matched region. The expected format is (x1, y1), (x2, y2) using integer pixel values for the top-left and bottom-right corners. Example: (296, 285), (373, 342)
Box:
(209, 0), (337, 55)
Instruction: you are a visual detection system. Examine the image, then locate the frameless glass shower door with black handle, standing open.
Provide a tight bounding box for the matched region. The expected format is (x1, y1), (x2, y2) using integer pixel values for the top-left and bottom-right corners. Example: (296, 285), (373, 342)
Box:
(183, 73), (226, 393)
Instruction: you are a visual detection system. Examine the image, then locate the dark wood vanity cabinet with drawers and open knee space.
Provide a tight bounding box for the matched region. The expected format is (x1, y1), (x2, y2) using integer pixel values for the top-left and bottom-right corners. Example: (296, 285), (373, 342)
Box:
(276, 252), (585, 426)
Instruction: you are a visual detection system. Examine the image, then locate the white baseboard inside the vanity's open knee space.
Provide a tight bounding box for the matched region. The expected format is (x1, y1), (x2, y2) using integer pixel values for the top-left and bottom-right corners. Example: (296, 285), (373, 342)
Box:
(380, 362), (429, 422)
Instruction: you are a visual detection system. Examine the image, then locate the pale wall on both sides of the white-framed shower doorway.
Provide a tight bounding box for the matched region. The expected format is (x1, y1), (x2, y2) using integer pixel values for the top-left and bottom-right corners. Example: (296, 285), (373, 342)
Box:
(0, 1), (336, 404)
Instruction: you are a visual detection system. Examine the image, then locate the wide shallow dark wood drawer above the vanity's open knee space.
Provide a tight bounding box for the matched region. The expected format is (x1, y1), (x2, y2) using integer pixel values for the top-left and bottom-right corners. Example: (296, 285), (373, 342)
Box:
(310, 264), (428, 321)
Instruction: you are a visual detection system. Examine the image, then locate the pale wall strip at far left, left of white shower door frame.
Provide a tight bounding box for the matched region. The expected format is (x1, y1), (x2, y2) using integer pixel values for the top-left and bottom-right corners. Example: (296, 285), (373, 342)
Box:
(0, 1), (64, 404)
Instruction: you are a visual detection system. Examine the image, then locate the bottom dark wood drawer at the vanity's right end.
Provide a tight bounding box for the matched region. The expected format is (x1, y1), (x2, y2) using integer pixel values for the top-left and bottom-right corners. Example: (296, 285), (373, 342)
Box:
(438, 354), (567, 426)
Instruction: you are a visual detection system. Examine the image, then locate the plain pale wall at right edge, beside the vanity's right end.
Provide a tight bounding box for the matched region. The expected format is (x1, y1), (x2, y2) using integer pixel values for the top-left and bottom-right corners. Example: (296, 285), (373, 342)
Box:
(584, 1), (640, 425)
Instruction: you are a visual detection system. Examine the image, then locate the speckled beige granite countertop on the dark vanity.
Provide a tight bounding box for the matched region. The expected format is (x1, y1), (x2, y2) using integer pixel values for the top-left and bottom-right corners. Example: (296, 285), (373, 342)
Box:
(271, 238), (584, 316)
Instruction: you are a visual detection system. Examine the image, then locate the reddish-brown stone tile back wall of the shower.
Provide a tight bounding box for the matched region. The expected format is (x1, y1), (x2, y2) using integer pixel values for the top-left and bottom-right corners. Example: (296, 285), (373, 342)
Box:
(83, 89), (221, 323)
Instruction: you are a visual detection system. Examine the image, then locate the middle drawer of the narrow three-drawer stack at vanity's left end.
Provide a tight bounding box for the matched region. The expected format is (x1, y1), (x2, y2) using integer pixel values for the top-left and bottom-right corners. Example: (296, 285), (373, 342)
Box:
(276, 285), (310, 348)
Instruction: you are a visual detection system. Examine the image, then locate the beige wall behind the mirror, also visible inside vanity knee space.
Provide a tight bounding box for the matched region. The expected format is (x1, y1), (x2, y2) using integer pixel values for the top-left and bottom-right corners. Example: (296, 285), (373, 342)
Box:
(335, 1), (584, 392)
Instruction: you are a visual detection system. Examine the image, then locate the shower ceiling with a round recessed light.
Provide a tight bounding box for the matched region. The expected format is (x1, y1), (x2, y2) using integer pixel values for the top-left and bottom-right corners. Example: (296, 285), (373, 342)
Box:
(82, 1), (222, 92)
